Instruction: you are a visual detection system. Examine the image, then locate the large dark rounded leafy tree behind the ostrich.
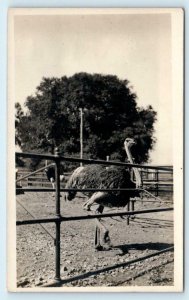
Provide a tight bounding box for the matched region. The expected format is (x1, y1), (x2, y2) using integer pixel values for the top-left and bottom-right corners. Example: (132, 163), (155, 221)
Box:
(16, 73), (156, 163)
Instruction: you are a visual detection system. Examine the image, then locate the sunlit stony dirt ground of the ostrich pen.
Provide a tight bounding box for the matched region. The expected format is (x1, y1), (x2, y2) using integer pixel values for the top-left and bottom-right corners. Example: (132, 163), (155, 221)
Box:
(16, 192), (174, 287)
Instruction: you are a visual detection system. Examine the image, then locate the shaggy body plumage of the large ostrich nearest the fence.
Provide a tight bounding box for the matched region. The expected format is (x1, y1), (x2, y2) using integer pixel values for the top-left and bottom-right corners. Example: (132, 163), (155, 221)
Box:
(66, 165), (139, 207)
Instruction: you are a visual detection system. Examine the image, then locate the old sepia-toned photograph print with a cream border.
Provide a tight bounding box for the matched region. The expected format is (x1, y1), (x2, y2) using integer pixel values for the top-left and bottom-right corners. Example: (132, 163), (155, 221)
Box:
(7, 8), (184, 292)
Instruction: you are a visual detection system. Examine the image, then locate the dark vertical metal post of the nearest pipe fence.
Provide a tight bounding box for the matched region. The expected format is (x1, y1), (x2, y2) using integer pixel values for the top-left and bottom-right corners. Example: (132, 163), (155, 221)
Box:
(55, 148), (61, 282)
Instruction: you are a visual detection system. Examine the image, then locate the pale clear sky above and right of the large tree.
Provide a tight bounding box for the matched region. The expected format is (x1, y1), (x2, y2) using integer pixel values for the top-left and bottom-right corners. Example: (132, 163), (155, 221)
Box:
(14, 13), (173, 165)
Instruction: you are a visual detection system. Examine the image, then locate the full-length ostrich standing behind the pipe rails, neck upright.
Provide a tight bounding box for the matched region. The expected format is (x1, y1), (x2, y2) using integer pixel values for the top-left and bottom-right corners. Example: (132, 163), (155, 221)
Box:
(65, 138), (141, 250)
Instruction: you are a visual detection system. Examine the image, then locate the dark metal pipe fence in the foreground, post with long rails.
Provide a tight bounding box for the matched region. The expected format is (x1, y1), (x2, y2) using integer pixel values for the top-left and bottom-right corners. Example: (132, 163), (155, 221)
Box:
(16, 149), (173, 283)
